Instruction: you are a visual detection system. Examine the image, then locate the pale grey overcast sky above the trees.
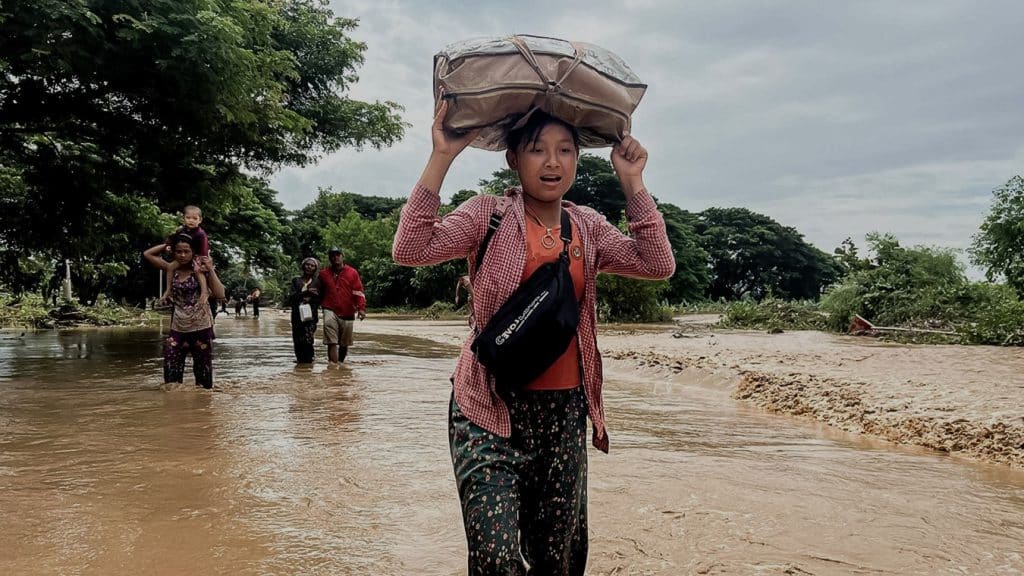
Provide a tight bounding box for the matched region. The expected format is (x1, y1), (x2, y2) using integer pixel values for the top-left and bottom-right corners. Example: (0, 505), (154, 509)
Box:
(271, 0), (1024, 258)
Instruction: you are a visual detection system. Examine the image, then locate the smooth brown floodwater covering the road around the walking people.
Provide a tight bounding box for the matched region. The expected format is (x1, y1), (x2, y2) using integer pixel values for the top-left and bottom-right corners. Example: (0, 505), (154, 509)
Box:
(0, 311), (1024, 575)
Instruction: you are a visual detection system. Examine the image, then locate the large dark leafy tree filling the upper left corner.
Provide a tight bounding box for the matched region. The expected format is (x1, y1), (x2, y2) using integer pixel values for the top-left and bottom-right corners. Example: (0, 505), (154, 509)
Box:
(0, 0), (406, 299)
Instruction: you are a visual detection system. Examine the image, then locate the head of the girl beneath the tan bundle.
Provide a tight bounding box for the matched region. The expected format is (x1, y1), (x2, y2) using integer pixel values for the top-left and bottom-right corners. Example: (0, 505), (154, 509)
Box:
(505, 111), (580, 202)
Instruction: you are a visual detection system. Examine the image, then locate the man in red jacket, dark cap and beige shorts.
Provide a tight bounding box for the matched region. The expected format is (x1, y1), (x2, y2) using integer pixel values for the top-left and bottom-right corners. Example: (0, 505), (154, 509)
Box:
(319, 246), (367, 364)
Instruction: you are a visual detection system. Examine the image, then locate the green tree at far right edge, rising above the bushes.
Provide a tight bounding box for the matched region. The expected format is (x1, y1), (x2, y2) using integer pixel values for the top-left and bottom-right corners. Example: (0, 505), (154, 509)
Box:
(971, 175), (1024, 298)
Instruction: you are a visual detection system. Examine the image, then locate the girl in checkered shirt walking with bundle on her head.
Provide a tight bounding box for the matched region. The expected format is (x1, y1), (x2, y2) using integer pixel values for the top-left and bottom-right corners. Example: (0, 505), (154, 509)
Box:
(392, 100), (675, 575)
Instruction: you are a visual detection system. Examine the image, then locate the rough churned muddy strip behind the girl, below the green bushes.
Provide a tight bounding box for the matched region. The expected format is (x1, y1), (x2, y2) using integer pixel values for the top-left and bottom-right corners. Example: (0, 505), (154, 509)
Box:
(374, 316), (1024, 468)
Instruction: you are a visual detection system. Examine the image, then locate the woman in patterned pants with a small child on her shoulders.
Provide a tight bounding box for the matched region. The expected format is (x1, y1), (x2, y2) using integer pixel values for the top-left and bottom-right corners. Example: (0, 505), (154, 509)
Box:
(142, 234), (224, 388)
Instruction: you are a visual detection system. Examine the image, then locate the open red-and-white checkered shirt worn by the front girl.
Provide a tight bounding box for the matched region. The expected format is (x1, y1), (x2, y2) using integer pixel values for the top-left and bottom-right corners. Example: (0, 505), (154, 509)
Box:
(391, 184), (676, 452)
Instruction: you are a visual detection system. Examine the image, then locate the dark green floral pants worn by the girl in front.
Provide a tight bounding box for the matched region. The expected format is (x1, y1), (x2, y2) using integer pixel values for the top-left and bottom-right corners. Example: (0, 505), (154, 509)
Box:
(449, 386), (588, 576)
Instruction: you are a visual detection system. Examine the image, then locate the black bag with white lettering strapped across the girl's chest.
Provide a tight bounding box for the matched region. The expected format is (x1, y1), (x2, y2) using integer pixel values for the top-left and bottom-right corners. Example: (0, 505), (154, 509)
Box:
(470, 206), (580, 390)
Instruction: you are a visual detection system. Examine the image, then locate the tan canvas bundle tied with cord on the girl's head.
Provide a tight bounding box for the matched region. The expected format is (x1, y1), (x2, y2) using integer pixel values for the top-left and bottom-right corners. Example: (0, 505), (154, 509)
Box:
(434, 35), (647, 151)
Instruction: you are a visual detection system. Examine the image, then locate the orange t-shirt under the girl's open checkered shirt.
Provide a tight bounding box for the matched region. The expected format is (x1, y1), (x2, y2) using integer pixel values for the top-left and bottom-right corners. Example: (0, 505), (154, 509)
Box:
(522, 215), (584, 390)
